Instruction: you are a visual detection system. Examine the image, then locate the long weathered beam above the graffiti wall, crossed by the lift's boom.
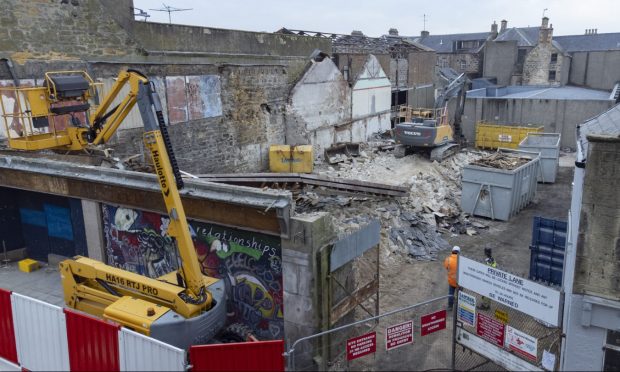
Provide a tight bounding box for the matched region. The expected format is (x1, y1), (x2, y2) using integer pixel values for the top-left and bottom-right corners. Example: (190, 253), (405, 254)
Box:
(0, 156), (293, 237)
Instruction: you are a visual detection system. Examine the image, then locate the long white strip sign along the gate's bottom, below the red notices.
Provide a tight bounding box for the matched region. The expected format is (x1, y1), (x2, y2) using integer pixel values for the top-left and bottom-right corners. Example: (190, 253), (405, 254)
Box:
(456, 328), (542, 371)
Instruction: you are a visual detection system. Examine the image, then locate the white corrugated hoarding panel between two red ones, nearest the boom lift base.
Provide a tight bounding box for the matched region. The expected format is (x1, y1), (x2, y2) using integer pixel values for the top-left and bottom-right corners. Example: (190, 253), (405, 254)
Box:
(118, 328), (186, 371)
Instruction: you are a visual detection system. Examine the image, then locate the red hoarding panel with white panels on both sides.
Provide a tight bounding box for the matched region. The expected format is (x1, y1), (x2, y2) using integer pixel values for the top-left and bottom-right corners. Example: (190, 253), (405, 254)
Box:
(65, 309), (120, 371)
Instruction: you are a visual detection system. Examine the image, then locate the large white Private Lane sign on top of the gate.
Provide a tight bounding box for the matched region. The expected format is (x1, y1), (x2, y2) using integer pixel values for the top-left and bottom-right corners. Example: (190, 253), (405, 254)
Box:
(458, 256), (560, 326)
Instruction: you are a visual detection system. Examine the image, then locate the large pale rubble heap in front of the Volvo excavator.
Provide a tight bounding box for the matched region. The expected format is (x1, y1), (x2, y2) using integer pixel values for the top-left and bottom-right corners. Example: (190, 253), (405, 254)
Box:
(296, 143), (486, 260)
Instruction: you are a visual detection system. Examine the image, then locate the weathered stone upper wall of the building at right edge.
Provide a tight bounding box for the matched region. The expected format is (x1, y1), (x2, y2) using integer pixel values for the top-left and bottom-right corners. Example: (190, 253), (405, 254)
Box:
(573, 136), (620, 301)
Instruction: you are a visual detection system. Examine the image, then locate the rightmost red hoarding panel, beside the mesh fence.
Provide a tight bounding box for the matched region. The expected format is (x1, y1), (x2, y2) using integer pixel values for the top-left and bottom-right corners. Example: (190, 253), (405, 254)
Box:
(189, 340), (284, 371)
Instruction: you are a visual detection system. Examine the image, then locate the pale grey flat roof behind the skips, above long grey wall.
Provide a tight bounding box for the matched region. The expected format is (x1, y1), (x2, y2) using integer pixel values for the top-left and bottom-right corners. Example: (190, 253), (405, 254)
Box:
(467, 85), (612, 101)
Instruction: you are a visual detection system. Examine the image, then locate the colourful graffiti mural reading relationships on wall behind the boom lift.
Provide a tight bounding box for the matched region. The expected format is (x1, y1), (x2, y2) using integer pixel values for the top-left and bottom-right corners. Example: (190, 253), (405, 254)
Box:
(102, 205), (284, 339)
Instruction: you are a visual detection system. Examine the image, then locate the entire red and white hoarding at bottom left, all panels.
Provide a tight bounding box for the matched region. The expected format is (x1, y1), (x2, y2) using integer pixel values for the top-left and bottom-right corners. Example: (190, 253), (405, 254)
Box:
(0, 288), (284, 371)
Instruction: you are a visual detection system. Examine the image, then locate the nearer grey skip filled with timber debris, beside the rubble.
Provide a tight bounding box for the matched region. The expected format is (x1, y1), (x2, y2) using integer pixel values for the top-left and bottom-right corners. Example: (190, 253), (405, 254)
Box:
(461, 148), (540, 221)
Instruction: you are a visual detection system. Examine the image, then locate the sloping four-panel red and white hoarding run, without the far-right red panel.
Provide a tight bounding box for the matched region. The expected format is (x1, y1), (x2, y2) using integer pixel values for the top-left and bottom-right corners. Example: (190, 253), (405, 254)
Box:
(0, 289), (187, 371)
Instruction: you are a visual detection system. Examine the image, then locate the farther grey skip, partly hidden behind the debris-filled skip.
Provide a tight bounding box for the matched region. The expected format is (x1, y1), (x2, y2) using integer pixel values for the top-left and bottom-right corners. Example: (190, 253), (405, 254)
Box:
(519, 133), (561, 183)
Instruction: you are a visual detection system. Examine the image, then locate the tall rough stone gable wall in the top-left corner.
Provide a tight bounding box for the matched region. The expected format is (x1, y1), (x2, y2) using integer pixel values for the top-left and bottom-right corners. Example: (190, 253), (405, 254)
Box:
(0, 0), (143, 64)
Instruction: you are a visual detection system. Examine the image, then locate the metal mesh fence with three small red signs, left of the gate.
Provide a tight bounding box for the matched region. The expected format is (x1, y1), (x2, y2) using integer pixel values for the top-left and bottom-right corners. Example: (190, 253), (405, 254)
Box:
(286, 296), (453, 371)
